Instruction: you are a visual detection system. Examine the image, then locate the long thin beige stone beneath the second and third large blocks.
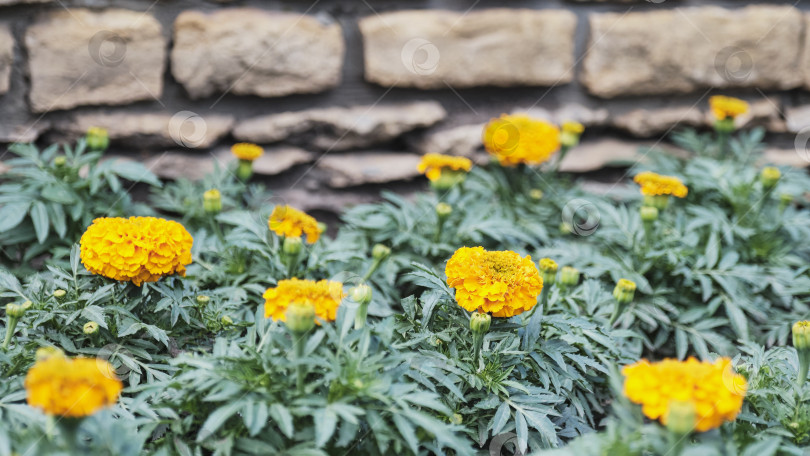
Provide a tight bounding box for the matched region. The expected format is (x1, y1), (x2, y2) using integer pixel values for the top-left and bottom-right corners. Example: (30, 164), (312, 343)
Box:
(233, 101), (447, 150)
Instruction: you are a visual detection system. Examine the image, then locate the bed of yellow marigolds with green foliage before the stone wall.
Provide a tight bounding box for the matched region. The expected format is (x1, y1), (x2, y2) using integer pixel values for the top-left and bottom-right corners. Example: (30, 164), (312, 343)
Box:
(0, 98), (810, 456)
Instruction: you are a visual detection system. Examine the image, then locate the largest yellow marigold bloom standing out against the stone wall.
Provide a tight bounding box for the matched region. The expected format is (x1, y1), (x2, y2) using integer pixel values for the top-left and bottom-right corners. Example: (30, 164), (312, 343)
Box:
(483, 114), (560, 166)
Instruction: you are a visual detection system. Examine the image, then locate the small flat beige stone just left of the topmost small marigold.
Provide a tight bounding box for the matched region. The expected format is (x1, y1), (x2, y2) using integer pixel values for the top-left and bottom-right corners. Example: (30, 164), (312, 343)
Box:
(613, 106), (706, 138)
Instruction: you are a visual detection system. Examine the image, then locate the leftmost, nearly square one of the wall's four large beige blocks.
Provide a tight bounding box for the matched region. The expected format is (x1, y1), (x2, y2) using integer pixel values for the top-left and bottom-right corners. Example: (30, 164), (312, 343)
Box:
(25, 9), (166, 112)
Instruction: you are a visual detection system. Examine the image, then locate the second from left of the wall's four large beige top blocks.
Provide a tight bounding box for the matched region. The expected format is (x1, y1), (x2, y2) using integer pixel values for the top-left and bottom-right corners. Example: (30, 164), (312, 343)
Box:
(172, 8), (344, 98)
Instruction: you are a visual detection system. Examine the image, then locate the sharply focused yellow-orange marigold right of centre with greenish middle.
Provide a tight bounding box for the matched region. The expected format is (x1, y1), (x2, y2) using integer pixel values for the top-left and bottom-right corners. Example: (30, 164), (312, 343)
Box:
(445, 247), (543, 317)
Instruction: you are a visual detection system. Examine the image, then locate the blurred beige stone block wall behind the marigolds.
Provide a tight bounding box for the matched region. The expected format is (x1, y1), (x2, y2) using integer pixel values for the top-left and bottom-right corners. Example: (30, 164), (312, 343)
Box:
(0, 0), (810, 214)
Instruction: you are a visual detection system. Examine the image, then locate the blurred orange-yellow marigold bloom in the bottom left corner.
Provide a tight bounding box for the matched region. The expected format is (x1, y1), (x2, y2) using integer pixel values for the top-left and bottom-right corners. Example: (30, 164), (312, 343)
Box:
(25, 355), (123, 418)
